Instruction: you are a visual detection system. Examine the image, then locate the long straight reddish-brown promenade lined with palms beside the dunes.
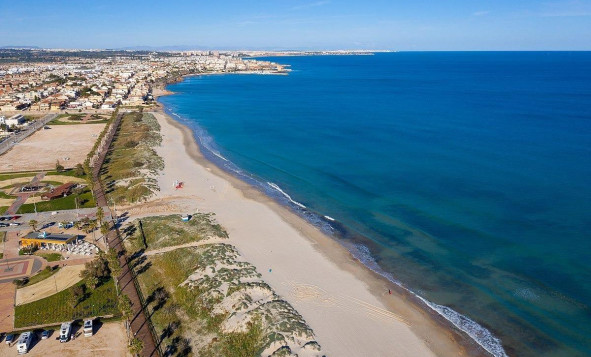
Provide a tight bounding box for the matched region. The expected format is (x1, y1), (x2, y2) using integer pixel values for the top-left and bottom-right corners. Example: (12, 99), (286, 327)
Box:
(92, 113), (161, 357)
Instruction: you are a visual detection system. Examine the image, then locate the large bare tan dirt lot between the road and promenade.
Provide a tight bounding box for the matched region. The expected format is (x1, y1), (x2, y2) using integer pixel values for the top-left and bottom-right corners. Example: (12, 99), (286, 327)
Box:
(0, 124), (105, 172)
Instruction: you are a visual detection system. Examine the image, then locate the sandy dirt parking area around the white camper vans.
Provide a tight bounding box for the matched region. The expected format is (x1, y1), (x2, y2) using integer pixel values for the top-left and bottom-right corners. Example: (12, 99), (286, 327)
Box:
(0, 322), (128, 357)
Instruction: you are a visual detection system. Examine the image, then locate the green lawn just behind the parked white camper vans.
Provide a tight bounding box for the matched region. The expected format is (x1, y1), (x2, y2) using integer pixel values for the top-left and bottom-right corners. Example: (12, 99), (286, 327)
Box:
(14, 279), (119, 328)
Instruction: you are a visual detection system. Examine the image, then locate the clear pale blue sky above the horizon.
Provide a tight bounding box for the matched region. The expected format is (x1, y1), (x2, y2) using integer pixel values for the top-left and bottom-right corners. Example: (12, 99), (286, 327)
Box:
(0, 0), (591, 51)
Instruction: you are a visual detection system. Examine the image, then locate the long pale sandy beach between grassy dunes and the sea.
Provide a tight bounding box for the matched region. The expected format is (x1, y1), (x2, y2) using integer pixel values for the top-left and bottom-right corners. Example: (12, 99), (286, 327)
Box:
(123, 106), (486, 356)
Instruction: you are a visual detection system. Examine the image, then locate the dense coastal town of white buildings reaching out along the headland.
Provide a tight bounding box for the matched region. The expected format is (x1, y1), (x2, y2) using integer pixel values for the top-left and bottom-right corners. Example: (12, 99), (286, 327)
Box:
(0, 51), (287, 113)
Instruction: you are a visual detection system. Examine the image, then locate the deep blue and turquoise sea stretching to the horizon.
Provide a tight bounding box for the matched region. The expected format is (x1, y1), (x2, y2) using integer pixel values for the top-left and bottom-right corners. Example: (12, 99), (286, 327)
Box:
(161, 52), (591, 356)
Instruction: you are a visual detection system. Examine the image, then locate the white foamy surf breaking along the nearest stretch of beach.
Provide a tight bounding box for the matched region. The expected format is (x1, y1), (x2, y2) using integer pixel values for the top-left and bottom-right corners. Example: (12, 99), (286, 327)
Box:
(349, 244), (508, 357)
